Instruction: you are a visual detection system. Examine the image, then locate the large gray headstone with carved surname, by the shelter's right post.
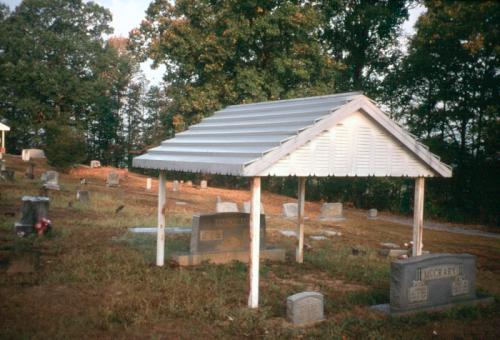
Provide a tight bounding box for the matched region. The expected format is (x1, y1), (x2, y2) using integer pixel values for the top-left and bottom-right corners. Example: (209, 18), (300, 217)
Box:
(390, 254), (476, 313)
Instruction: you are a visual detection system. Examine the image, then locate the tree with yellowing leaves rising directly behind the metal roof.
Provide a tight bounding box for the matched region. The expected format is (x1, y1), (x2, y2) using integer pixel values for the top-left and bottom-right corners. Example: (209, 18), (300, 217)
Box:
(130, 0), (337, 126)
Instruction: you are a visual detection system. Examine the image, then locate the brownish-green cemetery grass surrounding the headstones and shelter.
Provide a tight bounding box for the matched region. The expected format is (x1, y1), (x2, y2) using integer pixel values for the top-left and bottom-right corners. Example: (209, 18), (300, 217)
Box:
(0, 156), (500, 339)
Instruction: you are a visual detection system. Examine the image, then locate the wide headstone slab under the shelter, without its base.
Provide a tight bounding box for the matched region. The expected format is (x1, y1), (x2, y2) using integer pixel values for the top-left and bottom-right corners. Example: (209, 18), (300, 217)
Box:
(190, 213), (266, 253)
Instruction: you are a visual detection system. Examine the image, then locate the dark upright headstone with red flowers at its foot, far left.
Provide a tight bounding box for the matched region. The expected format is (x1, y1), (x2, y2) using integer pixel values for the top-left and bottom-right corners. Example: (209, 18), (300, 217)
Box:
(14, 196), (49, 235)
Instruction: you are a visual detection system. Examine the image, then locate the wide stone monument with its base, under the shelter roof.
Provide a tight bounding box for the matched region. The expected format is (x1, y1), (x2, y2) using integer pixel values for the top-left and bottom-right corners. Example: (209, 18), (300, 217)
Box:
(172, 213), (285, 266)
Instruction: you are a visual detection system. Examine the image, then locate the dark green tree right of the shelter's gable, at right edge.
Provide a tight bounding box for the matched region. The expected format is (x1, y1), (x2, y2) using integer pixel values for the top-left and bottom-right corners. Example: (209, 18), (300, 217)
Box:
(385, 1), (500, 224)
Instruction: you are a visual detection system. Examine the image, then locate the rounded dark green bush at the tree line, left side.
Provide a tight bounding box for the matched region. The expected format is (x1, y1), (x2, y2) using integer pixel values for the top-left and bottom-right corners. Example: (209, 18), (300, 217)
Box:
(45, 122), (87, 169)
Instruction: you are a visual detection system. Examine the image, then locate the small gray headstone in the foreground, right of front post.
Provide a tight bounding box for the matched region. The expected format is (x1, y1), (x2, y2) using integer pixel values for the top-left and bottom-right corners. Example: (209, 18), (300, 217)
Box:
(286, 292), (325, 325)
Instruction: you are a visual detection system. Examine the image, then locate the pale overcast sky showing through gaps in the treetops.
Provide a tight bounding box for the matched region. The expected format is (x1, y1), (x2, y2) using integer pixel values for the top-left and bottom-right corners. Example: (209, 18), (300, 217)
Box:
(0, 0), (425, 84)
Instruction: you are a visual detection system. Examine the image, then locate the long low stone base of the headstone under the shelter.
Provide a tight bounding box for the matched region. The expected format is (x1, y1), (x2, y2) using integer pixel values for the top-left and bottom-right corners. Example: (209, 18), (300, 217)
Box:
(171, 248), (285, 267)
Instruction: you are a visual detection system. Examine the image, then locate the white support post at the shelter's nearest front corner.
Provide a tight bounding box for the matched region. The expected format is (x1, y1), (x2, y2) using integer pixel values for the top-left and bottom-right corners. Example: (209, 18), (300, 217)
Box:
(248, 177), (260, 308)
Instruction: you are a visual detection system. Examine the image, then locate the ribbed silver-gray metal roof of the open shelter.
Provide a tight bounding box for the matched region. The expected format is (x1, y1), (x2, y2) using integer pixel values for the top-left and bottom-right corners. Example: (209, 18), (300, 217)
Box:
(133, 92), (454, 176)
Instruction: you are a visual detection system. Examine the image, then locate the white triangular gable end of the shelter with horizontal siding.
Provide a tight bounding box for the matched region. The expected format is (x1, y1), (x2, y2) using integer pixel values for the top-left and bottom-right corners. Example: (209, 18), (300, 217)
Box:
(261, 111), (435, 177)
